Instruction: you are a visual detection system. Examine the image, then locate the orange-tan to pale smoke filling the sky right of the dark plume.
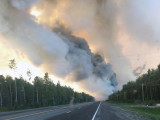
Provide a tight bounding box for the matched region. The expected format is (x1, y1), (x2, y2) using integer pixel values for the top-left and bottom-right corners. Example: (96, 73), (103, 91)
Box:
(33, 0), (160, 88)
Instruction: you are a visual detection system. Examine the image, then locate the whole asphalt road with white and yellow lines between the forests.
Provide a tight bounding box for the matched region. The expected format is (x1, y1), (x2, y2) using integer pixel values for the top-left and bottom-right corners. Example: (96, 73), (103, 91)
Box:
(0, 102), (148, 120)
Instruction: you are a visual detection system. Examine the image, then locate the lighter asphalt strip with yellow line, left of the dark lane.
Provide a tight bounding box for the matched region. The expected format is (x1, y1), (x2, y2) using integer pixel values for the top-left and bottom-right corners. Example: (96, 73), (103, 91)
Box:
(0, 102), (95, 120)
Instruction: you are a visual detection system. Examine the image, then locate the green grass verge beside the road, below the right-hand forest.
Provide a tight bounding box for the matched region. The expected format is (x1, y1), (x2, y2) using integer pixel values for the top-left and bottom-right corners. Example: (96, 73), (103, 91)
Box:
(121, 107), (160, 120)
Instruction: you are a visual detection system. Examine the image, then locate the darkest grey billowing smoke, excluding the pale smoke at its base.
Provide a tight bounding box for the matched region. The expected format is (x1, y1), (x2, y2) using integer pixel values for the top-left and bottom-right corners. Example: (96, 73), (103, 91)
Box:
(53, 24), (117, 86)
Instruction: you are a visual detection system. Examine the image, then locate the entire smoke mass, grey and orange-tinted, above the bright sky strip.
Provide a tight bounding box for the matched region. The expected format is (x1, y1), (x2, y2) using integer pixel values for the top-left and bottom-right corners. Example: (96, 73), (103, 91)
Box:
(0, 0), (160, 99)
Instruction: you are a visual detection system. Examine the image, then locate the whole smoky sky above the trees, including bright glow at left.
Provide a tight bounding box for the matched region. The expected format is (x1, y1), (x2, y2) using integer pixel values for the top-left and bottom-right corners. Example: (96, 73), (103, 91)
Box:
(0, 0), (160, 99)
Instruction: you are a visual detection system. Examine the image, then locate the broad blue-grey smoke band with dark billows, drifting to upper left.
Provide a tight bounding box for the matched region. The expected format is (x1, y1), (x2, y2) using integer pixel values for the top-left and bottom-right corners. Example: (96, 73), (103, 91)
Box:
(0, 0), (117, 99)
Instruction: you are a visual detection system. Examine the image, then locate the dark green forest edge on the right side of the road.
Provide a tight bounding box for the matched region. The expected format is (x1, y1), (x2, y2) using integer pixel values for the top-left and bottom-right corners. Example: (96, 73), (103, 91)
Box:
(109, 65), (160, 104)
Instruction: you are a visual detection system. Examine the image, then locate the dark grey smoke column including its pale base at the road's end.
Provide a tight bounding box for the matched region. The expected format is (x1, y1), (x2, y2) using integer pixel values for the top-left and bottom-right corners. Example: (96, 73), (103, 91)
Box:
(53, 24), (117, 99)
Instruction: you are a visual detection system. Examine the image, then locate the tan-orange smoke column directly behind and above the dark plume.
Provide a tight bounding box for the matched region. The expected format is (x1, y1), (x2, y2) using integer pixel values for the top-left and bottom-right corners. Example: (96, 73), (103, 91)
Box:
(34, 0), (136, 88)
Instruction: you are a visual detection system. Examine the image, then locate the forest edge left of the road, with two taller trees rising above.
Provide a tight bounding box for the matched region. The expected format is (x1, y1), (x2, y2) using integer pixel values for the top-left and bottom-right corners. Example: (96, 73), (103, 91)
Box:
(0, 60), (94, 110)
